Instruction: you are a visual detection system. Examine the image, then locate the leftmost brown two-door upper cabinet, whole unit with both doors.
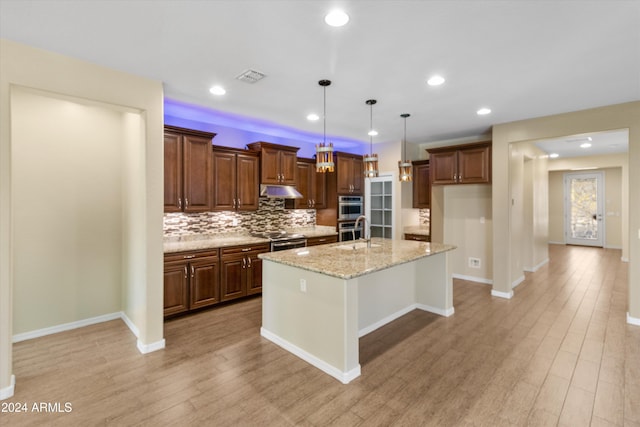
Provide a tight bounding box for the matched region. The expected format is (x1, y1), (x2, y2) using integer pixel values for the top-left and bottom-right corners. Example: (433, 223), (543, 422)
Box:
(164, 126), (216, 212)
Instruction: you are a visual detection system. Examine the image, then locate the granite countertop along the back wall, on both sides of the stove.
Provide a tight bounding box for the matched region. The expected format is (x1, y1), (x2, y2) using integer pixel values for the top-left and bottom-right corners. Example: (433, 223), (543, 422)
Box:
(163, 225), (338, 254)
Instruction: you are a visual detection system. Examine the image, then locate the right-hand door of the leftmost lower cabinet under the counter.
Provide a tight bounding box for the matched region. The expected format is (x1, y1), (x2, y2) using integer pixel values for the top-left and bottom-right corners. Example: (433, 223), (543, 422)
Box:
(189, 256), (220, 309)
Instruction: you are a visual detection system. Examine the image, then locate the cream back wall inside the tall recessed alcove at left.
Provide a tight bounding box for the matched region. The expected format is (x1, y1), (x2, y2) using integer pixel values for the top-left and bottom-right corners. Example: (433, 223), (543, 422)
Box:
(11, 88), (123, 334)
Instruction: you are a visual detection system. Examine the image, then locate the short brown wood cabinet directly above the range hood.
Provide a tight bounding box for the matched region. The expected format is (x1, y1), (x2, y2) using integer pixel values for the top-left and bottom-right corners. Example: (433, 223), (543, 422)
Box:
(247, 141), (300, 185)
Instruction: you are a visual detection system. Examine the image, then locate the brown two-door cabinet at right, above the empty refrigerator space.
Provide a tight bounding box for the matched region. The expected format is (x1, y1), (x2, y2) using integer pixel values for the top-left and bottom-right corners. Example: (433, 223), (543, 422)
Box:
(427, 141), (491, 185)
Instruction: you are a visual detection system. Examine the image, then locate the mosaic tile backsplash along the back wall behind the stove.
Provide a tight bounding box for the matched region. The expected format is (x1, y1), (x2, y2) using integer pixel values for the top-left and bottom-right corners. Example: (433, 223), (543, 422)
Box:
(163, 197), (316, 237)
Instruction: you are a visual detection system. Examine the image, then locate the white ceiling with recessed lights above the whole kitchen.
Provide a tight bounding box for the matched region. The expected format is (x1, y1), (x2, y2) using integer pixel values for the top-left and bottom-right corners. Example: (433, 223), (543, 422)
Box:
(0, 0), (640, 149)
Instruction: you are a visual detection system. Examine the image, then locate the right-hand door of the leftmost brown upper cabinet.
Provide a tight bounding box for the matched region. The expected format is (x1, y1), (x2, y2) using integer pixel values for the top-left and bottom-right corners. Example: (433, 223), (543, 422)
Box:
(183, 135), (213, 212)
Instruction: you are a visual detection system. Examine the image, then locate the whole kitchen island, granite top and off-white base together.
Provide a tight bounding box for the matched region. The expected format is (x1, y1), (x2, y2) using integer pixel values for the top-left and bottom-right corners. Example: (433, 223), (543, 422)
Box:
(260, 239), (455, 384)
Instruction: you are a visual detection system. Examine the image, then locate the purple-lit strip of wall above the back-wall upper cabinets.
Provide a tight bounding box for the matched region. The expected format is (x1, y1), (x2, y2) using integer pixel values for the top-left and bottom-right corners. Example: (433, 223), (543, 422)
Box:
(164, 98), (366, 158)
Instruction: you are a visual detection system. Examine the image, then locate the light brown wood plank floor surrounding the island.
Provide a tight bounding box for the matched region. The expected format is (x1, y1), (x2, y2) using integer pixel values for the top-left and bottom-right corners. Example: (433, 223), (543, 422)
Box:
(0, 245), (640, 426)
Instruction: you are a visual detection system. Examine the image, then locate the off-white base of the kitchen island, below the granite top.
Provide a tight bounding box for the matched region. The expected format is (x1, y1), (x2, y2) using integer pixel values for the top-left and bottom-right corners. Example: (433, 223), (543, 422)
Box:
(261, 249), (454, 384)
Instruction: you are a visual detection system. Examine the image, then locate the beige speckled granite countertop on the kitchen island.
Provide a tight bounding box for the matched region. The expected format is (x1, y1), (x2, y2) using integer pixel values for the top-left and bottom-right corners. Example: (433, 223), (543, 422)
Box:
(258, 238), (456, 279)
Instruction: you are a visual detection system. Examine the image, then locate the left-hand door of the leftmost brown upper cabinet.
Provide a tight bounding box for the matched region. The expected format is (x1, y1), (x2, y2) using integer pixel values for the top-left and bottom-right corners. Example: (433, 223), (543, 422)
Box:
(164, 132), (182, 212)
